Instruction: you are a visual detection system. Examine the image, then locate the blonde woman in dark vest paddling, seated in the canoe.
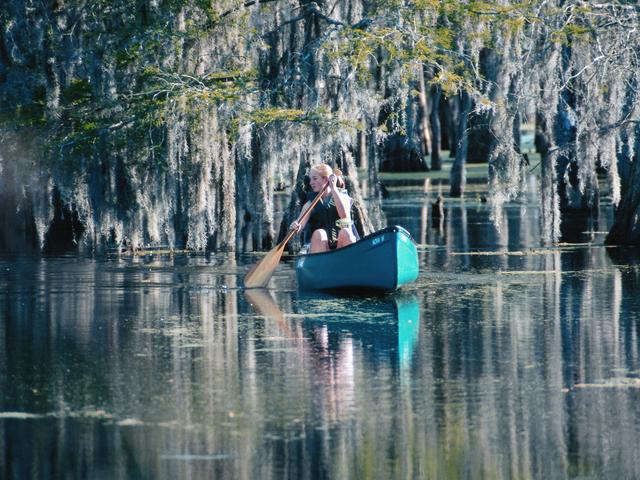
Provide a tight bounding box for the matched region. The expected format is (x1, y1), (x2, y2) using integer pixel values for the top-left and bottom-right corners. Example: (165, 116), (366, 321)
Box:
(291, 163), (357, 253)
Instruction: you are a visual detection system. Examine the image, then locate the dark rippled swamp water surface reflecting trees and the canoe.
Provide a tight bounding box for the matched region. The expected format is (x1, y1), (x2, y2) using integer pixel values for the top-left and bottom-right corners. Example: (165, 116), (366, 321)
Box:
(0, 189), (640, 479)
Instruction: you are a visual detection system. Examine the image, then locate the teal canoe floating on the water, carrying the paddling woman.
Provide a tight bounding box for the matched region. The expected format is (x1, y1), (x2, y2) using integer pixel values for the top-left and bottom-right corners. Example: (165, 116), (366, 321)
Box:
(296, 225), (418, 292)
